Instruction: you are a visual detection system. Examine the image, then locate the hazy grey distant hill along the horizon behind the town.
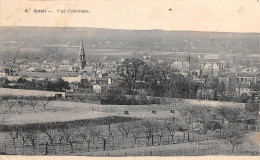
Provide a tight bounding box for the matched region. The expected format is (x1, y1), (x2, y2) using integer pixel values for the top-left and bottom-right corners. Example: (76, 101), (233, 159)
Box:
(0, 27), (260, 54)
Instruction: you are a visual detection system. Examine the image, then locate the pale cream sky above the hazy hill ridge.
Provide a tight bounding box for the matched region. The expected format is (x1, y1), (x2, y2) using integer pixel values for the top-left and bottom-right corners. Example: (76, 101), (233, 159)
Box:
(0, 0), (260, 33)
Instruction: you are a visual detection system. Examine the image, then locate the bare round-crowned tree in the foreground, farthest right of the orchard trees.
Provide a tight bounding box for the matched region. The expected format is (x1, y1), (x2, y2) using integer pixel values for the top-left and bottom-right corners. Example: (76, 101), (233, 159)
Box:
(224, 123), (245, 152)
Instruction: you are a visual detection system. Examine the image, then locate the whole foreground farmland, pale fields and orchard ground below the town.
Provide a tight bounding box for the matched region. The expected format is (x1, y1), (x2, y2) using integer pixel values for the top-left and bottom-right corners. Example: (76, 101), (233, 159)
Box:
(0, 100), (259, 156)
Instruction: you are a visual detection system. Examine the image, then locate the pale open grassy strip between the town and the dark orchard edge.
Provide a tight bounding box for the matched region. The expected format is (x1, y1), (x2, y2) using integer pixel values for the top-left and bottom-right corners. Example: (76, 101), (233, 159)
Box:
(0, 100), (246, 124)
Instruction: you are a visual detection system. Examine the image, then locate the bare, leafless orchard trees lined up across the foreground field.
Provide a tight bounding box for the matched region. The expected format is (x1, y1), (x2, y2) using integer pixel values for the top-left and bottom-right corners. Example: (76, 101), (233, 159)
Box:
(4, 115), (251, 154)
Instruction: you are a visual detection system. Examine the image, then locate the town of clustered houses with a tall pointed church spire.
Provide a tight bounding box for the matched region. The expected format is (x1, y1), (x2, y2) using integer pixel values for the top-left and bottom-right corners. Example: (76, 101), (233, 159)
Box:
(0, 41), (260, 103)
